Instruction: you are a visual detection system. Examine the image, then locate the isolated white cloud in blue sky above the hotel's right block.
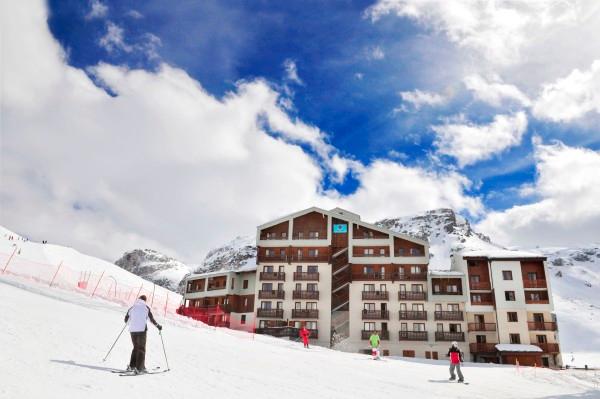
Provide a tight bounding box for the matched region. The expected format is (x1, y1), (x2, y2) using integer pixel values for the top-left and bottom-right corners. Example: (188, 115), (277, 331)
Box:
(432, 112), (527, 167)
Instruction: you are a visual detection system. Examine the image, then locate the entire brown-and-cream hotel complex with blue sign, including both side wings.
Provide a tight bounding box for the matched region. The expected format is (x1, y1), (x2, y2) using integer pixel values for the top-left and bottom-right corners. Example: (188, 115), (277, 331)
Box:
(180, 207), (560, 366)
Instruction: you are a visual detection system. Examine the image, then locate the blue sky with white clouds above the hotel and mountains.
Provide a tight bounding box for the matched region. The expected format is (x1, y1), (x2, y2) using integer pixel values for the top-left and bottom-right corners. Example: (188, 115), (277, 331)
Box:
(0, 0), (600, 263)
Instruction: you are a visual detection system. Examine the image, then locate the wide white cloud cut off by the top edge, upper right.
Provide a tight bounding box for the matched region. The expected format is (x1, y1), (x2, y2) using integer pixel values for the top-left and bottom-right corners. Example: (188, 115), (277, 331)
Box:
(365, 0), (580, 65)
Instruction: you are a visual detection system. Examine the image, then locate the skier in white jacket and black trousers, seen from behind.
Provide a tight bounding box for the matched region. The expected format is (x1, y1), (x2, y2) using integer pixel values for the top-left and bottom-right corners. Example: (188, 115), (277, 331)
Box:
(125, 295), (162, 373)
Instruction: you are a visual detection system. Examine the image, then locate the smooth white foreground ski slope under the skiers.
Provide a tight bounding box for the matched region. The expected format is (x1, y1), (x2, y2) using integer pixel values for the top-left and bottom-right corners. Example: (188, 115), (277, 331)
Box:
(0, 275), (600, 399)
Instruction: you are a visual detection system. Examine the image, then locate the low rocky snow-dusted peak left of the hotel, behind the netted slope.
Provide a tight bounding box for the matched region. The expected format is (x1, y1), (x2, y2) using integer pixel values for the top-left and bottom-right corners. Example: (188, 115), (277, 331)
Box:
(115, 249), (191, 291)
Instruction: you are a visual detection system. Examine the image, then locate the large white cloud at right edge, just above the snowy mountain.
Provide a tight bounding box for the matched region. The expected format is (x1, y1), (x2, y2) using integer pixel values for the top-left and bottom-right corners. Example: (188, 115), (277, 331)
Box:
(476, 139), (600, 246)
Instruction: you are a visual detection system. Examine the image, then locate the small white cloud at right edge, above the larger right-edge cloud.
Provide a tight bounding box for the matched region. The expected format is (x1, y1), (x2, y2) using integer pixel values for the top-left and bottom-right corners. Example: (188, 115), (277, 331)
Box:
(533, 60), (600, 122)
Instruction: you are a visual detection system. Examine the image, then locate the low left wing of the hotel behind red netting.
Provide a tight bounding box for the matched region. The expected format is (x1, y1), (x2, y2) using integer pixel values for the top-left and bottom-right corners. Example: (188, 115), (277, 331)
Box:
(179, 267), (256, 329)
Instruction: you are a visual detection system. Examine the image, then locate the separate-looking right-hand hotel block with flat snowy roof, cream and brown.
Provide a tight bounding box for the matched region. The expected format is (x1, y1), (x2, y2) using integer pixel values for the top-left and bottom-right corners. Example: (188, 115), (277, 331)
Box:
(452, 250), (561, 367)
